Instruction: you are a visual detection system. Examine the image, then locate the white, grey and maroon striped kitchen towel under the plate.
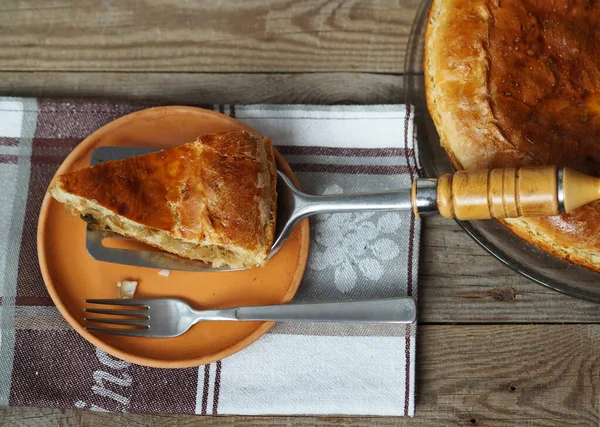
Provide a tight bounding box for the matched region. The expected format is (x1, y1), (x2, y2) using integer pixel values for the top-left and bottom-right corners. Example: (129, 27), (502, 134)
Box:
(0, 98), (420, 416)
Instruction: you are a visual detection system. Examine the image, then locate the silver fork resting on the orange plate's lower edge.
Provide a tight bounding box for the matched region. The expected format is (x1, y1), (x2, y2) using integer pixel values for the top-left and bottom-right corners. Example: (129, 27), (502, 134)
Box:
(83, 297), (416, 338)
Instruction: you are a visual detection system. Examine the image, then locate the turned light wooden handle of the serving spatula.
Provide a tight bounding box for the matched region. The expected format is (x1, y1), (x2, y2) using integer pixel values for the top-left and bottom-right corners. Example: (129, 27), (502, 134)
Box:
(437, 166), (600, 220)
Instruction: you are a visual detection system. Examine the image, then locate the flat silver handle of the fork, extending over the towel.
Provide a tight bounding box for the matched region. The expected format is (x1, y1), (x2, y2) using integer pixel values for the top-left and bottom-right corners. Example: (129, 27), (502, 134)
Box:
(227, 298), (417, 323)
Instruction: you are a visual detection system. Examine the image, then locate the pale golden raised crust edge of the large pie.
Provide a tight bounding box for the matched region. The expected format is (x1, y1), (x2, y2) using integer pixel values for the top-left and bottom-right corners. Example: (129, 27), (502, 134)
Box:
(424, 0), (600, 272)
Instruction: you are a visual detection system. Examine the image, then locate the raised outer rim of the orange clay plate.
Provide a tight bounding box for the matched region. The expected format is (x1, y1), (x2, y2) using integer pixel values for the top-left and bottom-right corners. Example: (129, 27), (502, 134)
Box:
(36, 105), (310, 368)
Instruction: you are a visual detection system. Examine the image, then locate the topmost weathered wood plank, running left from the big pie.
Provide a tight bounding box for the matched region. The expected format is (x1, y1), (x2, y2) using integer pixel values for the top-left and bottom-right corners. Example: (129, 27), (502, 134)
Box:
(0, 0), (420, 73)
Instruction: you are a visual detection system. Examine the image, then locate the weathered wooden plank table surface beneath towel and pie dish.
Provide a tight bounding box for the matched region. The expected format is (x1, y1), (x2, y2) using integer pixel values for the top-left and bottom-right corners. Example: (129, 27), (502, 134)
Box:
(0, 0), (600, 427)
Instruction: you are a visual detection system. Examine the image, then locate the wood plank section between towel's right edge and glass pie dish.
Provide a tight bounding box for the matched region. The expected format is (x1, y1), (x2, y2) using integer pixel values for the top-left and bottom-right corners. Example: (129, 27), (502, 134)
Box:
(419, 217), (600, 323)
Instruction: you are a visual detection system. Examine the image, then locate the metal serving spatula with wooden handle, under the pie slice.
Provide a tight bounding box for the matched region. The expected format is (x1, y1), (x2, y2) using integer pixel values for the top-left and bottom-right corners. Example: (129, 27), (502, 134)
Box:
(86, 147), (600, 272)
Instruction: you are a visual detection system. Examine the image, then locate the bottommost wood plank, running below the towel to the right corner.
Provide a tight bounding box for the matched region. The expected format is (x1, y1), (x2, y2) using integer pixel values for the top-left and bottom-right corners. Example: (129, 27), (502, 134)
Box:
(0, 325), (600, 427)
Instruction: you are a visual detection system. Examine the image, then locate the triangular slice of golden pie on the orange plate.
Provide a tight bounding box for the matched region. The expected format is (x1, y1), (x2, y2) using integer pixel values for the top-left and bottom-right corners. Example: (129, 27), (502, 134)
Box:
(49, 132), (277, 267)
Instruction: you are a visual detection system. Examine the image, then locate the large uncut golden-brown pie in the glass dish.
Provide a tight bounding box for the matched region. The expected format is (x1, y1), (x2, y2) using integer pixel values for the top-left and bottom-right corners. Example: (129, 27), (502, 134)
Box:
(425, 0), (600, 271)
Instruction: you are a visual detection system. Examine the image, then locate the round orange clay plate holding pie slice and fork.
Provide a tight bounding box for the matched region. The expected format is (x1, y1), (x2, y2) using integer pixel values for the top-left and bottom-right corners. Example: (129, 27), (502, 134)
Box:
(37, 106), (309, 368)
